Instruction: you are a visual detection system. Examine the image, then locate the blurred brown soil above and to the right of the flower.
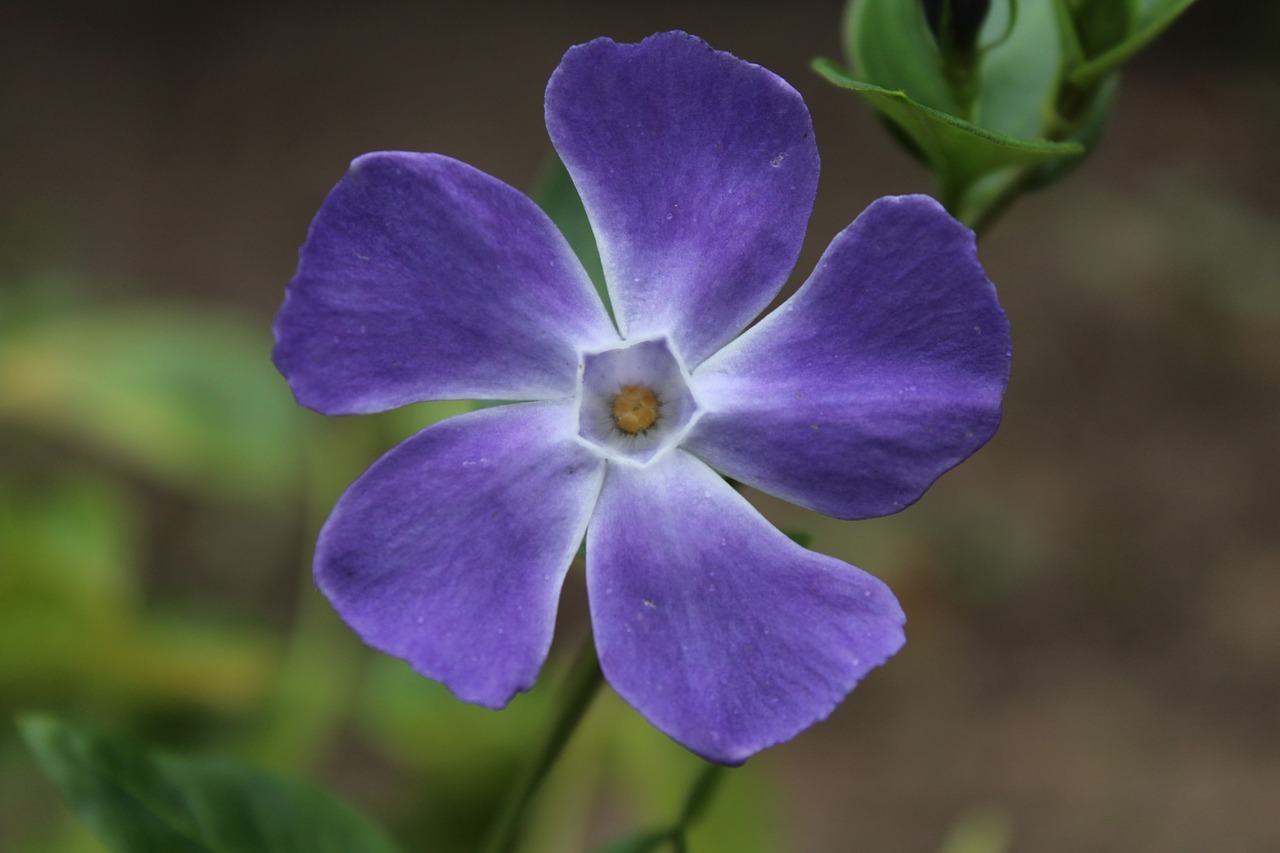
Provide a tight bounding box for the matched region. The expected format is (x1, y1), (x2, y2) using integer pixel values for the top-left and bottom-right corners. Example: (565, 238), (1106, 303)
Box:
(0, 0), (1280, 853)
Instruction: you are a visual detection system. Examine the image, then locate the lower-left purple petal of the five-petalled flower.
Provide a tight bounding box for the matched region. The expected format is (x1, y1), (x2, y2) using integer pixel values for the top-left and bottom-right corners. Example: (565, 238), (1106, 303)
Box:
(315, 401), (604, 708)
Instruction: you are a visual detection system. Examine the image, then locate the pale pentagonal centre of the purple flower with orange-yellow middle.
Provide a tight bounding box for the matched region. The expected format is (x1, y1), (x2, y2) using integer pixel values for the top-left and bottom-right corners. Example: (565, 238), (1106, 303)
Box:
(579, 338), (698, 465)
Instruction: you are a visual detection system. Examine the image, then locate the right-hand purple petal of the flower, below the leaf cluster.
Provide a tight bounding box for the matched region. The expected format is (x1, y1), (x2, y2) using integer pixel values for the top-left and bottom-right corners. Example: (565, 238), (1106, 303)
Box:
(684, 196), (1010, 519)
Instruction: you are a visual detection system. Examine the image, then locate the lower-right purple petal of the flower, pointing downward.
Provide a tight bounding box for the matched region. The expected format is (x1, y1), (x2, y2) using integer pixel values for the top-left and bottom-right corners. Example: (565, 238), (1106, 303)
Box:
(586, 450), (905, 765)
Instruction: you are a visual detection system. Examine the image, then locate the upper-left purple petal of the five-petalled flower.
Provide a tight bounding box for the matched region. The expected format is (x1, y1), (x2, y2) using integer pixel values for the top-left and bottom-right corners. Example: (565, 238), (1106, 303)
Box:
(274, 151), (618, 415)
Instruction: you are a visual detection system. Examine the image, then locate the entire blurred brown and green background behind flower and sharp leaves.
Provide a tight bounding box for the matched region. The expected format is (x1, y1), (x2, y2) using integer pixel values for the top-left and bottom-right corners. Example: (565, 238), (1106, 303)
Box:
(0, 0), (1280, 853)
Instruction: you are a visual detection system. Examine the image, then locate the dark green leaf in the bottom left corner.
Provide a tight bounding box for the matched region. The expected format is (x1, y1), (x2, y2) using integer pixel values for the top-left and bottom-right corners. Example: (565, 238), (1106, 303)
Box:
(19, 716), (396, 853)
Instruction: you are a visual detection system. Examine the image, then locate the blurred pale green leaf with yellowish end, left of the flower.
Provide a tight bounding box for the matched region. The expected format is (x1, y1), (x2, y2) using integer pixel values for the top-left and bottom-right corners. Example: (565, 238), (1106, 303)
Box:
(0, 307), (301, 503)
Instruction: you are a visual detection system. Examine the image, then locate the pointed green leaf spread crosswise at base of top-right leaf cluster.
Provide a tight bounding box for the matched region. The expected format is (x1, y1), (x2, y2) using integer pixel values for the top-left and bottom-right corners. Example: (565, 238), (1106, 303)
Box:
(814, 59), (1084, 204)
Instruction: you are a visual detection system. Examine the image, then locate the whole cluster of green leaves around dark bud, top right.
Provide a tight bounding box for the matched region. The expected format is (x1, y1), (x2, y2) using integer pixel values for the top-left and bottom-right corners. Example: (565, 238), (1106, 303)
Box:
(814, 0), (1194, 229)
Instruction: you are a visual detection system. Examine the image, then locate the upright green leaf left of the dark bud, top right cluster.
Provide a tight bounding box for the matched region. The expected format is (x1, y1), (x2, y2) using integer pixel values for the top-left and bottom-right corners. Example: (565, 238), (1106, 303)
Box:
(842, 0), (961, 115)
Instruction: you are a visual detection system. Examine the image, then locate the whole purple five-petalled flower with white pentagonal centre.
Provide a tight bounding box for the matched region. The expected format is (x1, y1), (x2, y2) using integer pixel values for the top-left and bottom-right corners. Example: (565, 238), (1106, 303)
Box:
(275, 32), (1010, 765)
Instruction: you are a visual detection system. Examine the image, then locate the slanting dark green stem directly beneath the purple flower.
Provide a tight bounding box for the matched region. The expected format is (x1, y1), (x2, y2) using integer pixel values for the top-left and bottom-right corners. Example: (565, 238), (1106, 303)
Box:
(481, 637), (604, 853)
